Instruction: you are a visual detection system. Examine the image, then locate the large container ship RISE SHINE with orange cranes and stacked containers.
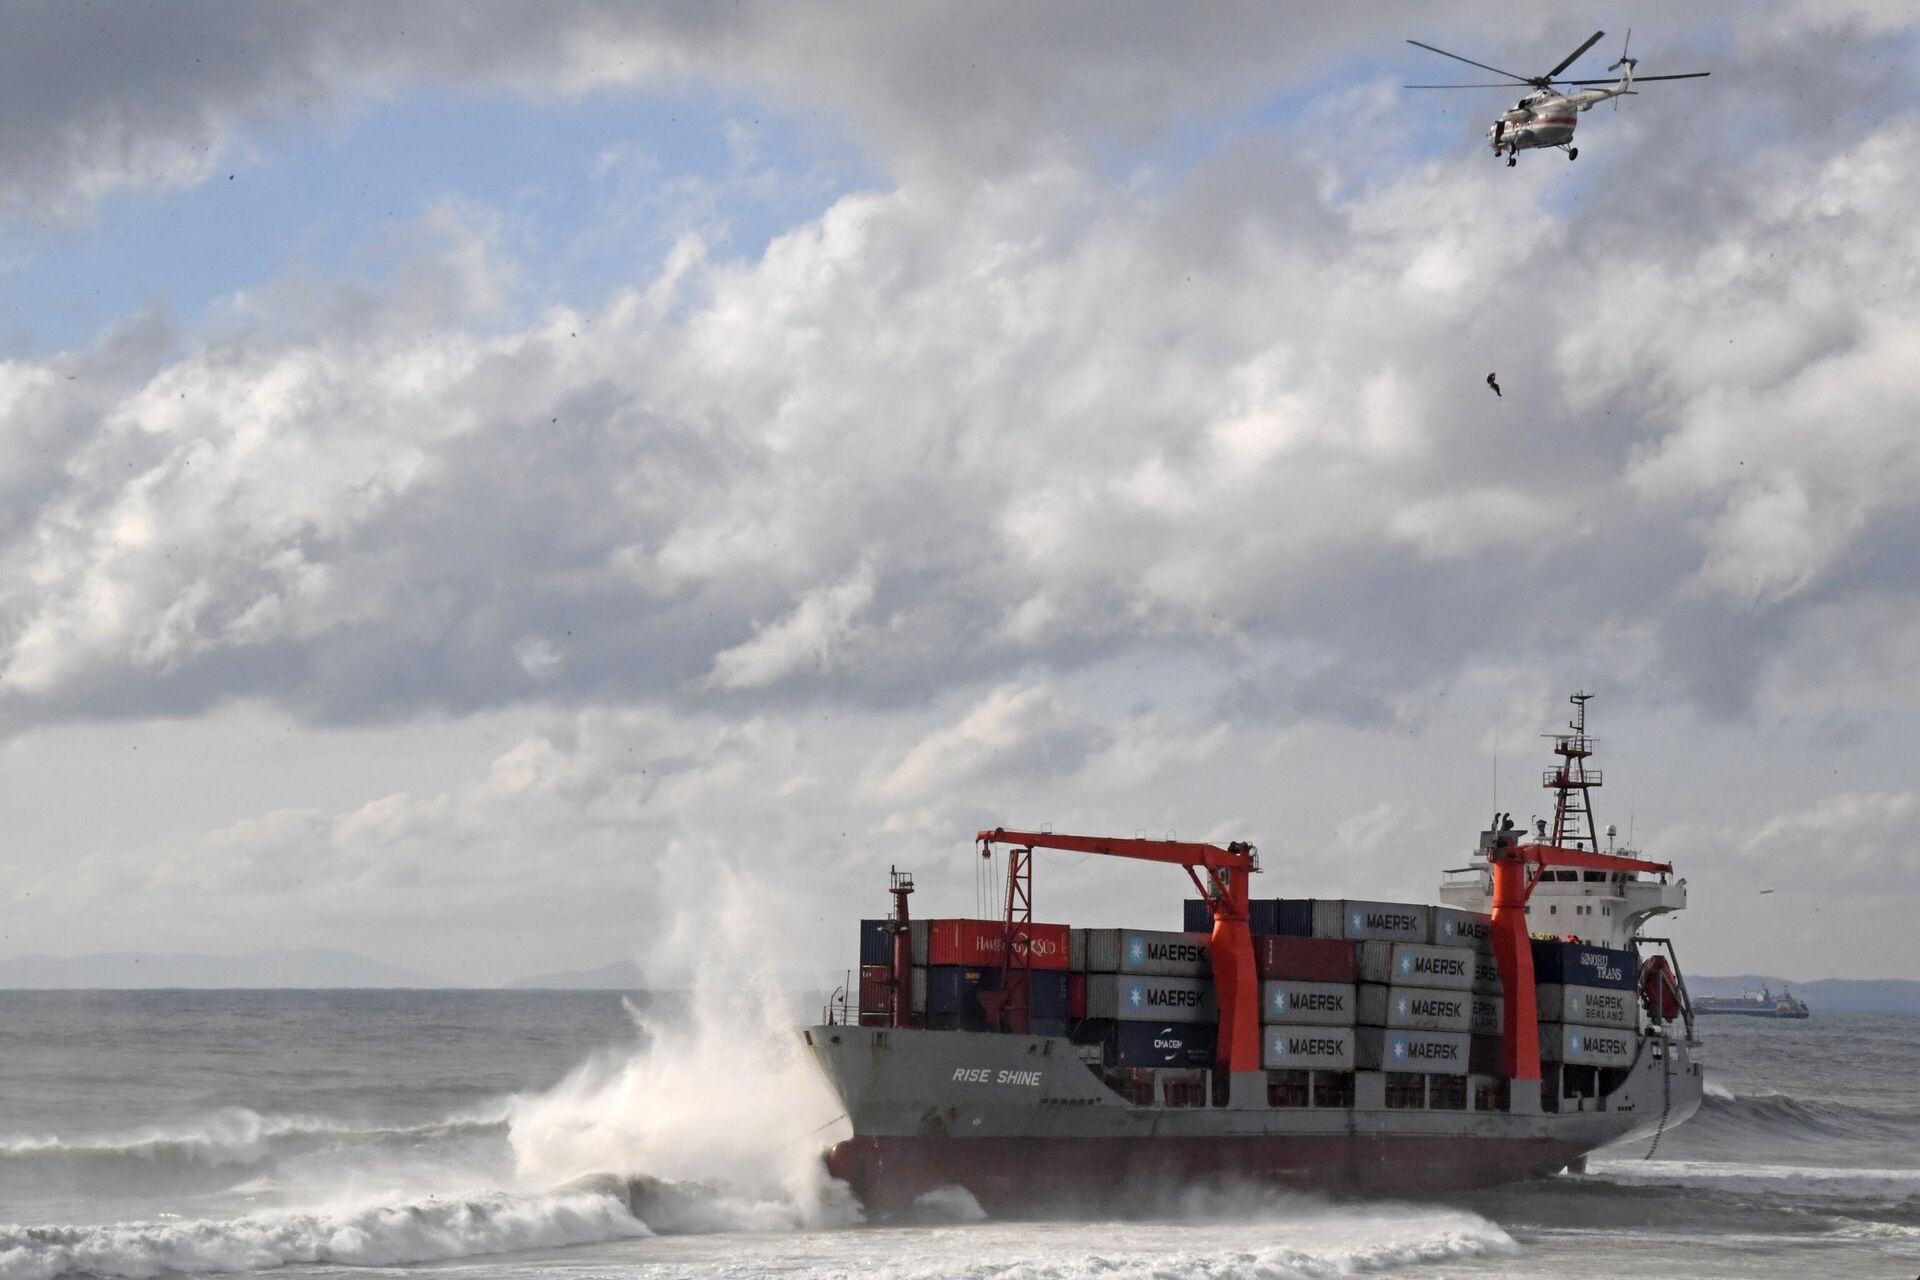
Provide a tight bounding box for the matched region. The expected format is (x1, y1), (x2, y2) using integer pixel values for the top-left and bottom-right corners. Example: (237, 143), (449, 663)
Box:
(801, 693), (1703, 1215)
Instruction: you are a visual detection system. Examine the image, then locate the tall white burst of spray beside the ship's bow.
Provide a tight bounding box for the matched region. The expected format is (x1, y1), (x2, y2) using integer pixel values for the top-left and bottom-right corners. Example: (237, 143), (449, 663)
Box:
(509, 869), (858, 1230)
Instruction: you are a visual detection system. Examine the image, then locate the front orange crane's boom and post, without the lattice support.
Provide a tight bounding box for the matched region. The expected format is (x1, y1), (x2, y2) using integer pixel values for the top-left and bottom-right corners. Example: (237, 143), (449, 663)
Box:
(975, 827), (1260, 1073)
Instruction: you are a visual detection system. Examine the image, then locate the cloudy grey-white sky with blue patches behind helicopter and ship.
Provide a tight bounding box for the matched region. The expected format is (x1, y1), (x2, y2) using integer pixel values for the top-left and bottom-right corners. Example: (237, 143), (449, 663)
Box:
(0, 0), (1920, 983)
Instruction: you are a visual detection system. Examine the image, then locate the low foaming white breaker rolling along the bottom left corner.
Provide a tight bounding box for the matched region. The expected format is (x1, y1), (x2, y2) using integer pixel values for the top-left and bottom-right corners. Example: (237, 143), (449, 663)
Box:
(0, 1192), (649, 1280)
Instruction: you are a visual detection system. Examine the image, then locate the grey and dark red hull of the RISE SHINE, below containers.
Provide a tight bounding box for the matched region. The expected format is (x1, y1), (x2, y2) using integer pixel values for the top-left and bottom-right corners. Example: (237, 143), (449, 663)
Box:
(806, 1027), (1703, 1215)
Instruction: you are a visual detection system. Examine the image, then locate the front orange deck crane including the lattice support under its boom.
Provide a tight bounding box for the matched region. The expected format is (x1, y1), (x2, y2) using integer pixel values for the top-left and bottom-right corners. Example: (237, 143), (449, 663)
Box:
(975, 827), (1267, 1073)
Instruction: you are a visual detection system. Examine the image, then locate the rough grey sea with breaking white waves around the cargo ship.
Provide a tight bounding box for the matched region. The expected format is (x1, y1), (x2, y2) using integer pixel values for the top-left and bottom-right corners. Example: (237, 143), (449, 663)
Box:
(0, 988), (1920, 1280)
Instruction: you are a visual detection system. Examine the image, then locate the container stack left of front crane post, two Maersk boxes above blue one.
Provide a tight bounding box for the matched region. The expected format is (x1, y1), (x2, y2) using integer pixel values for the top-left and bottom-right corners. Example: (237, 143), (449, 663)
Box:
(1069, 929), (1219, 1067)
